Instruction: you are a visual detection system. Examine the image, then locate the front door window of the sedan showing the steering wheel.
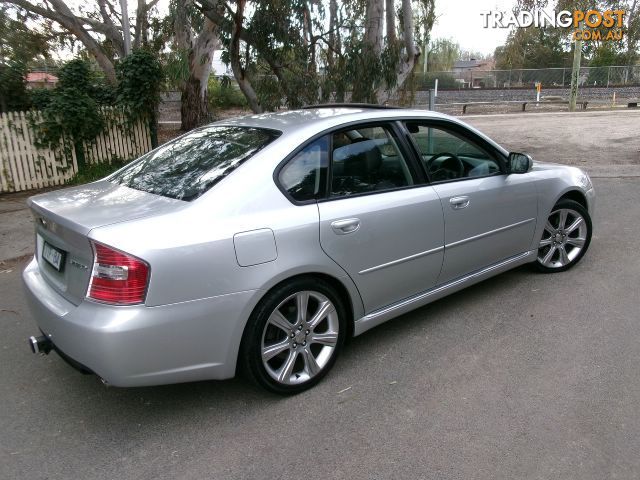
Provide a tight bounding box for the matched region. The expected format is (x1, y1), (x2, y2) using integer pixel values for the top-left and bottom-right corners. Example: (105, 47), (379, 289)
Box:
(408, 123), (500, 182)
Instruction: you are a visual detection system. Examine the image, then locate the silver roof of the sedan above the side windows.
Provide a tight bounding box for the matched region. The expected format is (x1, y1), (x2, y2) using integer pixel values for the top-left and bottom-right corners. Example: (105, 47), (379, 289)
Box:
(216, 106), (458, 135)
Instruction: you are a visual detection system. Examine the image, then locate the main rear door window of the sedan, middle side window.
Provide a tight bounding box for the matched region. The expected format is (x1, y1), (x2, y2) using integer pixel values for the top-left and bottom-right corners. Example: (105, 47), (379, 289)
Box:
(331, 126), (413, 197)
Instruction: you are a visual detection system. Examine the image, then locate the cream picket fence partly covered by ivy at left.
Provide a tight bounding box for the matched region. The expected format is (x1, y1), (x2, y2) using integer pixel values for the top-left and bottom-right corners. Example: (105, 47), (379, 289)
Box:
(0, 109), (151, 193)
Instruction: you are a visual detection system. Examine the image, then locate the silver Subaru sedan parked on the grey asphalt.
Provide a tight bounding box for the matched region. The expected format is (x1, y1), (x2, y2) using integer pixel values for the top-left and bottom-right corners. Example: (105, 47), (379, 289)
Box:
(23, 106), (594, 394)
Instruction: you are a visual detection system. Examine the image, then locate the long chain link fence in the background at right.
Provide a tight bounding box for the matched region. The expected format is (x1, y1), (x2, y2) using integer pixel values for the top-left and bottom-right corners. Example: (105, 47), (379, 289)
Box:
(416, 65), (640, 90)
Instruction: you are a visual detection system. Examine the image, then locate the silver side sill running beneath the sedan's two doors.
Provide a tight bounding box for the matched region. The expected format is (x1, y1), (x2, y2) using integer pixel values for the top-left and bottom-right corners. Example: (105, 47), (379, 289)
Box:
(354, 251), (536, 335)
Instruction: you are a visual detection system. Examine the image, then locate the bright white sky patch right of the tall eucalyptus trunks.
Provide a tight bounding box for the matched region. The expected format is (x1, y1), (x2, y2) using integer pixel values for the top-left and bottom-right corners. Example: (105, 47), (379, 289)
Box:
(431, 0), (515, 54)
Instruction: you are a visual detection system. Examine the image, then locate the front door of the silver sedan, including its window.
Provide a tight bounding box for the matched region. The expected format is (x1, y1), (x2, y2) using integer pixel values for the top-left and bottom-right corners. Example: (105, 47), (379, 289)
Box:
(407, 122), (537, 284)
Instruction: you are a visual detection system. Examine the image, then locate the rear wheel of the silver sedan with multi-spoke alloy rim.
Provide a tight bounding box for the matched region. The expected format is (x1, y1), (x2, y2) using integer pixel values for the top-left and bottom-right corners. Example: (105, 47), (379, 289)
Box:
(241, 278), (347, 395)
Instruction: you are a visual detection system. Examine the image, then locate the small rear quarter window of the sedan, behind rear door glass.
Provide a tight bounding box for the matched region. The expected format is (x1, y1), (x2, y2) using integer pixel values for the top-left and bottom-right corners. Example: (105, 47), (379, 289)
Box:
(279, 137), (329, 202)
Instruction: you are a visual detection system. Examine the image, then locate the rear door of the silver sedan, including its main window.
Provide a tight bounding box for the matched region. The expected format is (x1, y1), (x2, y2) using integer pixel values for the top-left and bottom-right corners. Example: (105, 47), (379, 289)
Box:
(318, 124), (444, 313)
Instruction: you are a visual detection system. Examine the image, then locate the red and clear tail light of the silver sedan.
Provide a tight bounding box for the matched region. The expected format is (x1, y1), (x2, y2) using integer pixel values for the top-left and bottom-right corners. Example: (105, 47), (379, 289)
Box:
(87, 242), (149, 305)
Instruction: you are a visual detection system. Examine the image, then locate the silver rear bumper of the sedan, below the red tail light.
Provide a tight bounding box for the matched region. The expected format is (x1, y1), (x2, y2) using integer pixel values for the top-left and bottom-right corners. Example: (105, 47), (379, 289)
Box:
(23, 259), (256, 387)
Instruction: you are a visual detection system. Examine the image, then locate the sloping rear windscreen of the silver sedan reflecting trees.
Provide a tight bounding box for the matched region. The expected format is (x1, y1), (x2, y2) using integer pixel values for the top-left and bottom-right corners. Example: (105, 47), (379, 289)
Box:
(107, 125), (280, 201)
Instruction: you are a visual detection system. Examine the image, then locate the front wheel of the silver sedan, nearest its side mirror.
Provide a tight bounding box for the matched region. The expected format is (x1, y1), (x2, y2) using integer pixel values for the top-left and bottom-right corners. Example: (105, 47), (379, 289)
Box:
(535, 199), (592, 273)
